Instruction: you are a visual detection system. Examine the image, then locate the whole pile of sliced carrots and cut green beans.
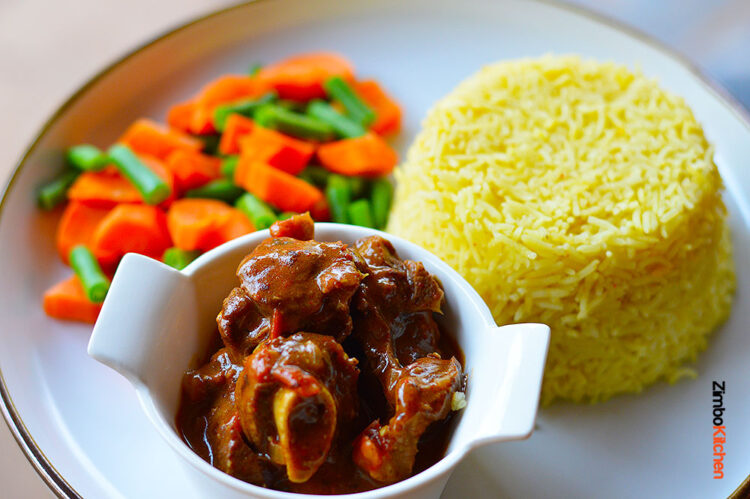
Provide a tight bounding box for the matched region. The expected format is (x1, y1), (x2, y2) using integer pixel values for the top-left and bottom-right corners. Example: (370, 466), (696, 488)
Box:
(37, 52), (401, 322)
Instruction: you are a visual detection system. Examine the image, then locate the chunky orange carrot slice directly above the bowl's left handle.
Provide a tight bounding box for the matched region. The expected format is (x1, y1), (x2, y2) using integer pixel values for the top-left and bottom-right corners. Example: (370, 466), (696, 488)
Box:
(92, 204), (172, 258)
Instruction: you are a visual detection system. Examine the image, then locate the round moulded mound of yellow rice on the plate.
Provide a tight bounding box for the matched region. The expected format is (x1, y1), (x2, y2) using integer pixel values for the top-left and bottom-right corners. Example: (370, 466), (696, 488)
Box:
(388, 56), (735, 403)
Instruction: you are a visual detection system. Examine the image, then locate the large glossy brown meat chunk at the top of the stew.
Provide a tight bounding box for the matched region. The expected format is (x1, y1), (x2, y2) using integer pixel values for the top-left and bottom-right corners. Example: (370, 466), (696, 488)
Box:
(237, 237), (364, 341)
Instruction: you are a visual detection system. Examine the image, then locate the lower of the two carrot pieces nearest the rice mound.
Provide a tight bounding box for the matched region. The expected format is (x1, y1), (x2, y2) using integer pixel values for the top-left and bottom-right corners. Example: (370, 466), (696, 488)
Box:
(318, 132), (398, 176)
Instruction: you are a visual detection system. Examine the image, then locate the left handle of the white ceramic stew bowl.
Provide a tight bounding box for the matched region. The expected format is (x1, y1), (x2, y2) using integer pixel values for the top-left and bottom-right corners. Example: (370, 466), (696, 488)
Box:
(88, 253), (195, 386)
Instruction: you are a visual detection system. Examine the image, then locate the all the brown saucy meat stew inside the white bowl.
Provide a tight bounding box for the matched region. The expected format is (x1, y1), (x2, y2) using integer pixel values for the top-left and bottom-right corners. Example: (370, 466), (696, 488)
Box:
(177, 215), (466, 494)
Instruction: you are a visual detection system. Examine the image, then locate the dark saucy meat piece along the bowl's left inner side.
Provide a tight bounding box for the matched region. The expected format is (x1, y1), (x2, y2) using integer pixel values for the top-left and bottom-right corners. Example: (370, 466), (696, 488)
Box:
(183, 349), (272, 485)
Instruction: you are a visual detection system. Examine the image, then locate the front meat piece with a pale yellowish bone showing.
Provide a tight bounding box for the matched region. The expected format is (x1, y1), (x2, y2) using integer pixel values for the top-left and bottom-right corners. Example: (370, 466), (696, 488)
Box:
(236, 333), (359, 483)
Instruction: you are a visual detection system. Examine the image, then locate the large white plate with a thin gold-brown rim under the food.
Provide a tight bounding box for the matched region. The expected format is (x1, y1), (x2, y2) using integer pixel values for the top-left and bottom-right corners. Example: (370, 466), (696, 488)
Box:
(0, 0), (750, 498)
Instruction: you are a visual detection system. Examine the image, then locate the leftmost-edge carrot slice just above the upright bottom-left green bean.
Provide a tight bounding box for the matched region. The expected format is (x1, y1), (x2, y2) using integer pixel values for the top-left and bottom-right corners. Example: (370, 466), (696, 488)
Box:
(56, 201), (117, 268)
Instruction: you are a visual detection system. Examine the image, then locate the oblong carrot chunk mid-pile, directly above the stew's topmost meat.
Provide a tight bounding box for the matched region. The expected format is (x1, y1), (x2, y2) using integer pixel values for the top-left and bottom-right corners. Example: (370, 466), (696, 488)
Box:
(234, 161), (323, 213)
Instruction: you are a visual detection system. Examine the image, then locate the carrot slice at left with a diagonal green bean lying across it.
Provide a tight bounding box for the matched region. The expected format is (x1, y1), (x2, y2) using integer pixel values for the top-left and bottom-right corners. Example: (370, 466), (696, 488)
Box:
(68, 155), (175, 208)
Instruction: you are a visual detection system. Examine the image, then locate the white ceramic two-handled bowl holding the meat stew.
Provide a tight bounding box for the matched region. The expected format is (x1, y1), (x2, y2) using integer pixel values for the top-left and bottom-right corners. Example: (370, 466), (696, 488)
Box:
(88, 224), (549, 499)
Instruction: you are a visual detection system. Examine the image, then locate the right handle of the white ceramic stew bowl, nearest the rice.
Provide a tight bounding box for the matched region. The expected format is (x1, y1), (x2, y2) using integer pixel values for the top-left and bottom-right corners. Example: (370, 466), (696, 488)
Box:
(469, 324), (550, 447)
